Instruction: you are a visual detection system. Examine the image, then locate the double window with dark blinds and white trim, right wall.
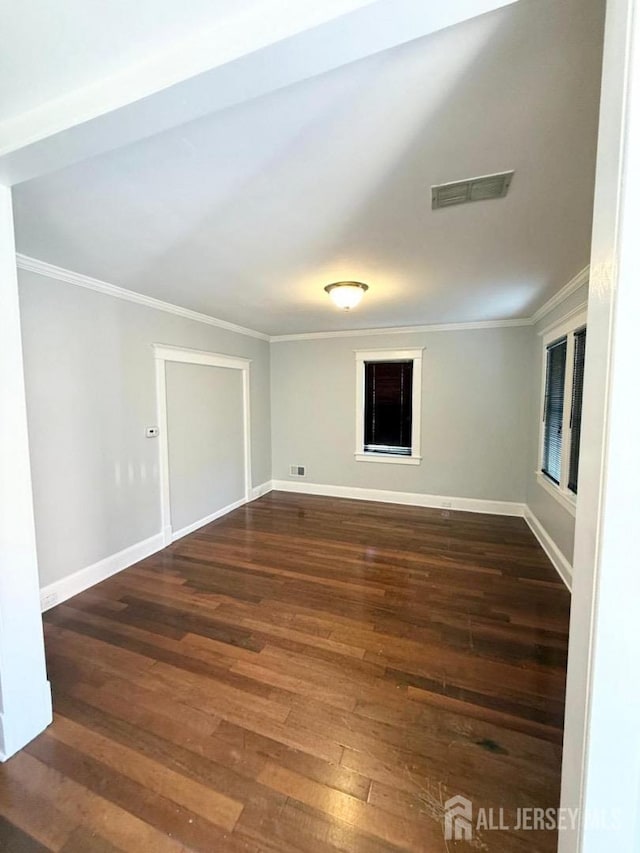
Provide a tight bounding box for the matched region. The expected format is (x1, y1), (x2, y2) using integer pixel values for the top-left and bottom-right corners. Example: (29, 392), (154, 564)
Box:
(538, 313), (587, 513)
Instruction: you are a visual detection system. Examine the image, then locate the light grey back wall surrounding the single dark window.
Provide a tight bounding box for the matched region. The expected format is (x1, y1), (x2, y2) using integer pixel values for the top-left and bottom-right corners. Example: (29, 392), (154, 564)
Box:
(271, 326), (532, 502)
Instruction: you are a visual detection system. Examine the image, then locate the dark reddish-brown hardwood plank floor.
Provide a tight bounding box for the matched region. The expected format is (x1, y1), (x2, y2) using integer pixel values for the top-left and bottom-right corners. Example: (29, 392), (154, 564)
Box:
(0, 492), (569, 853)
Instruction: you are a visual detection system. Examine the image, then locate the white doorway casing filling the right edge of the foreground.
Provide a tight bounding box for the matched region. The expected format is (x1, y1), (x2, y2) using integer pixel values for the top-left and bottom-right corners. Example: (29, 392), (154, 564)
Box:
(558, 0), (640, 853)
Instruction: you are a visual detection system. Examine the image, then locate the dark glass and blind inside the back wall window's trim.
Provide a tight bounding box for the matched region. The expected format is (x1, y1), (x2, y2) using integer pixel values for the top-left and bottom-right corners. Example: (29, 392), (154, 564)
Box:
(364, 361), (413, 456)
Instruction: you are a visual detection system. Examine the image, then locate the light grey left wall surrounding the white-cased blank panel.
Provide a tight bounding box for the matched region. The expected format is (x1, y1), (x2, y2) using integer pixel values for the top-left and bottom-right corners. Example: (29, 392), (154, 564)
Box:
(19, 271), (271, 586)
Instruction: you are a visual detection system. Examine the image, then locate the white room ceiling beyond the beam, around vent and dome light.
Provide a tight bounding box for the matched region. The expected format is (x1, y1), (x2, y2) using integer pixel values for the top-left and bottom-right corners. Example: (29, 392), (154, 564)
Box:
(14, 0), (604, 334)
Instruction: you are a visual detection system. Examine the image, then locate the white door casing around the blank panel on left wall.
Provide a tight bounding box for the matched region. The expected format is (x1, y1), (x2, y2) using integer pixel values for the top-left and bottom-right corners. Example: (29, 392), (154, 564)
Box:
(152, 344), (251, 545)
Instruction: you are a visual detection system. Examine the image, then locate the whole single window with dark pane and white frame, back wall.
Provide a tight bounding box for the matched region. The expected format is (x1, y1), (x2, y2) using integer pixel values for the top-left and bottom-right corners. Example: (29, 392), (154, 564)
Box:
(356, 349), (422, 465)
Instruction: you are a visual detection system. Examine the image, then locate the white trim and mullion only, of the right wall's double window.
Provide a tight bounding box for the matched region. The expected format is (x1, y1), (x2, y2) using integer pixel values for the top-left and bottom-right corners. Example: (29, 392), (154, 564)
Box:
(536, 312), (587, 516)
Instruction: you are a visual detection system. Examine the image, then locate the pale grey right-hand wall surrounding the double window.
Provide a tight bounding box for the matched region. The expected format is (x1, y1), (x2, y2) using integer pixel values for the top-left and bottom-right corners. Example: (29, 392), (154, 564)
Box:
(526, 285), (588, 564)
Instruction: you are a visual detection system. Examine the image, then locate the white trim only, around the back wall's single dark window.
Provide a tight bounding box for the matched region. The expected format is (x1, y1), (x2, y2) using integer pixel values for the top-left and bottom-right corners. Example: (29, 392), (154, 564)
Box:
(354, 347), (424, 465)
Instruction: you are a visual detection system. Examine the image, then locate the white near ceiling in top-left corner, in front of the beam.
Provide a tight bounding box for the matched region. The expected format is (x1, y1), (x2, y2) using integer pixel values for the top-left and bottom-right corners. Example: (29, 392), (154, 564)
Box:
(0, 0), (372, 124)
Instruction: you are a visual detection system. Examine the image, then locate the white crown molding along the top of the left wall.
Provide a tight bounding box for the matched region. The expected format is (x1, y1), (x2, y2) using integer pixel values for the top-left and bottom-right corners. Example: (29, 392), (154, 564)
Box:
(16, 254), (269, 341)
